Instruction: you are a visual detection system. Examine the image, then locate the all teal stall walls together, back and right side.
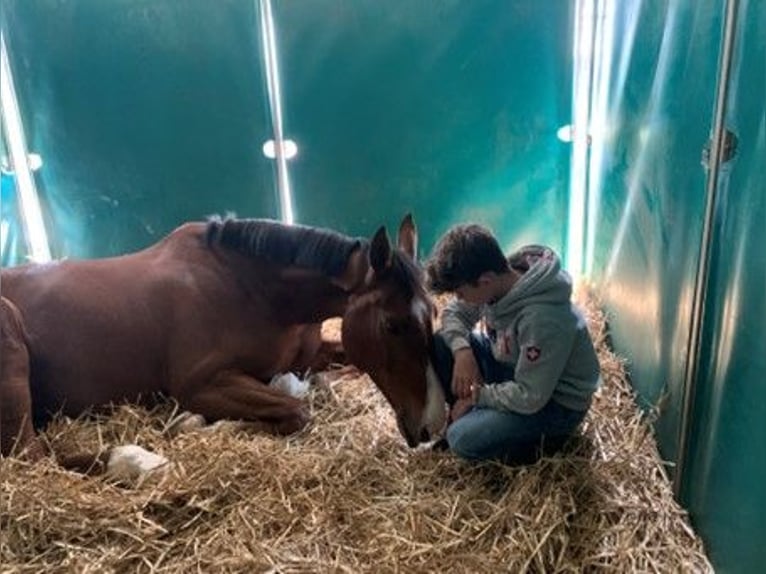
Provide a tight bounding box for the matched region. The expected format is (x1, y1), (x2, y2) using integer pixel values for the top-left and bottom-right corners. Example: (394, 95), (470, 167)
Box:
(2, 0), (766, 572)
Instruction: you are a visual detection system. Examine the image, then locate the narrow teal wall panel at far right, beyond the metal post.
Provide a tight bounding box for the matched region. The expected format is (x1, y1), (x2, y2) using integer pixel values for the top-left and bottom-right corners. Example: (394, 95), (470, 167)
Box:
(682, 0), (766, 572)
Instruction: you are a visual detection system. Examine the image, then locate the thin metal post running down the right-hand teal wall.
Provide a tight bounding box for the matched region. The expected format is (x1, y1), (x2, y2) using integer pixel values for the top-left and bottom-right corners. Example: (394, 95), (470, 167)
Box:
(673, 0), (739, 496)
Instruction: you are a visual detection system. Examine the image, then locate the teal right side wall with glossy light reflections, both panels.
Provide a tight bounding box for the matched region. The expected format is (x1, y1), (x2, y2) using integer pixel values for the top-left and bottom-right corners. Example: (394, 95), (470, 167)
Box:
(593, 0), (766, 573)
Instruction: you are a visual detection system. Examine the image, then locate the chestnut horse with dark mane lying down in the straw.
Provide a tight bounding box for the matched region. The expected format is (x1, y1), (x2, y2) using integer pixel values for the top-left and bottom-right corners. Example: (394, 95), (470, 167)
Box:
(0, 215), (445, 480)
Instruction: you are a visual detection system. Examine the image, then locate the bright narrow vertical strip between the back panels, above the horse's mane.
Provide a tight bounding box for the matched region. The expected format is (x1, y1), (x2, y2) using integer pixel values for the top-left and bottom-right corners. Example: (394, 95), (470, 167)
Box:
(259, 0), (294, 223)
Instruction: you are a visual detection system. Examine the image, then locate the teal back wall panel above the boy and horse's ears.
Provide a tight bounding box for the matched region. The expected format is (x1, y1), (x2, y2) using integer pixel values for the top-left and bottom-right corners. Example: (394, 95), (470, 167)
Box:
(274, 0), (572, 252)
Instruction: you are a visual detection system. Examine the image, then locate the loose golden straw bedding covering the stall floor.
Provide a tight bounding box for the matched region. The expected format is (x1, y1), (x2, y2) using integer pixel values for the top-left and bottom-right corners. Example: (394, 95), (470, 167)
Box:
(0, 297), (712, 574)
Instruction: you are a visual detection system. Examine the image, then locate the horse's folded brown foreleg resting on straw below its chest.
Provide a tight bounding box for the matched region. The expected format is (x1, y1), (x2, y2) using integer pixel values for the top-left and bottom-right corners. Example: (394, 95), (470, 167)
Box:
(174, 371), (309, 435)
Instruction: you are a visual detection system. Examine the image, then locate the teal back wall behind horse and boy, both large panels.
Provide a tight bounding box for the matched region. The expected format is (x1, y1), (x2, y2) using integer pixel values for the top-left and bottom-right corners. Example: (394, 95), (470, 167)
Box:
(4, 0), (573, 257)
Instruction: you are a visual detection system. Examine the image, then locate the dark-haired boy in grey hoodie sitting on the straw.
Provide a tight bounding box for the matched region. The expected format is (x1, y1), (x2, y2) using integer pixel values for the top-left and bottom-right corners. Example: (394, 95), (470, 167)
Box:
(426, 224), (599, 463)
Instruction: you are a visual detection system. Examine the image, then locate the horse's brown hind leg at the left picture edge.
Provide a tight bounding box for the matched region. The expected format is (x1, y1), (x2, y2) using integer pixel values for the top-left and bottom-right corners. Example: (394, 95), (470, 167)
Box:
(0, 297), (45, 460)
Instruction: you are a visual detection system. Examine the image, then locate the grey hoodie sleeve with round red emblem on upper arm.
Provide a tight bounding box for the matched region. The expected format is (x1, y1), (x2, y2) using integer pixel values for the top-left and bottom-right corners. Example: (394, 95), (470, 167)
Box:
(476, 313), (575, 414)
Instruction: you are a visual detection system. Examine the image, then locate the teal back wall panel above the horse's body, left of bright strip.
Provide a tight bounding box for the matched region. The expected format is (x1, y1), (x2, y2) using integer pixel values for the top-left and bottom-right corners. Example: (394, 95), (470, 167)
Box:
(3, 0), (277, 257)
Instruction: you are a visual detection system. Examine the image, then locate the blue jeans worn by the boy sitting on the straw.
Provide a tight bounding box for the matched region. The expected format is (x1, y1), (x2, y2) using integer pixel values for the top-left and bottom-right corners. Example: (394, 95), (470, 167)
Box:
(434, 333), (585, 464)
